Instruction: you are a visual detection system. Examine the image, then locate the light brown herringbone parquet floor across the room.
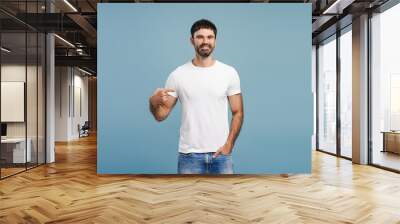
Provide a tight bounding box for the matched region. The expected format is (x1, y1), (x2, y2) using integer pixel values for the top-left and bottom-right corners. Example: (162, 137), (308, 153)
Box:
(0, 134), (400, 224)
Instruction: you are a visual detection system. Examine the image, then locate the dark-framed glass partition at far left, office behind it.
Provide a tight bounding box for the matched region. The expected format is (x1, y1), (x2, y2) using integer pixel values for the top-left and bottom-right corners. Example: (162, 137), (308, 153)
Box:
(0, 1), (46, 179)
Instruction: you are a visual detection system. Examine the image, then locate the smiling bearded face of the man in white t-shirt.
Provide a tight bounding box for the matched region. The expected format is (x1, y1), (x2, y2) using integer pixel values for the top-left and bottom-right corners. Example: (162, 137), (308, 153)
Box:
(190, 28), (216, 58)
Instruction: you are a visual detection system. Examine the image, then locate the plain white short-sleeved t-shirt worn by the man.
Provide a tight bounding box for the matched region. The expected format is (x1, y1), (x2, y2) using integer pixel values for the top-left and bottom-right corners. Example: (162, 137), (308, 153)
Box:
(165, 60), (241, 153)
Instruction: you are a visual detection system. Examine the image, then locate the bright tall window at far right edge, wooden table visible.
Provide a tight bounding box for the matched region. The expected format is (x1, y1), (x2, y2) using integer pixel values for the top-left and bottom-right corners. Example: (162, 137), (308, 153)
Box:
(370, 4), (400, 172)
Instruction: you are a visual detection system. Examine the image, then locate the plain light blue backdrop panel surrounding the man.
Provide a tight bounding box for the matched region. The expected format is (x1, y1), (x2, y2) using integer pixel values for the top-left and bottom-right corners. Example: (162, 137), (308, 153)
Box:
(97, 3), (313, 174)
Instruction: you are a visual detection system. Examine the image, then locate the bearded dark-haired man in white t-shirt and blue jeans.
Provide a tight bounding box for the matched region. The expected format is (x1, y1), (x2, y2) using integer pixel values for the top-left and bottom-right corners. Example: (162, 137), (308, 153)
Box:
(149, 19), (243, 174)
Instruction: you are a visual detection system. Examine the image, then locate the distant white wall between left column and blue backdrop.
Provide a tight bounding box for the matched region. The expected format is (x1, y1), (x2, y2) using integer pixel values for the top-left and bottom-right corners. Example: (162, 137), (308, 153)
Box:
(55, 67), (88, 141)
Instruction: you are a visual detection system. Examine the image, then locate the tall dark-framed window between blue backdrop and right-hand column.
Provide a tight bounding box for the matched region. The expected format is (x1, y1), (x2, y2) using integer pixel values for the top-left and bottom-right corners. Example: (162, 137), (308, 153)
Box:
(316, 25), (352, 159)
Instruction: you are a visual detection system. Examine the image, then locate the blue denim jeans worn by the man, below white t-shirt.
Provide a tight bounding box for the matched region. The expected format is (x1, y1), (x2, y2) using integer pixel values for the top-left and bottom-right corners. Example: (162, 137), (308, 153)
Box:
(178, 152), (233, 174)
